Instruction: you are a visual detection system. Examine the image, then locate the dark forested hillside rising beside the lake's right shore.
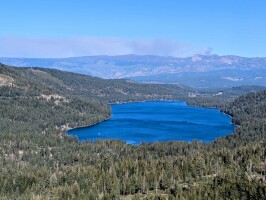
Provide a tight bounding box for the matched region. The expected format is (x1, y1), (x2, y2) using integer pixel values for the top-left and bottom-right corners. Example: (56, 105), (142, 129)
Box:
(221, 90), (266, 145)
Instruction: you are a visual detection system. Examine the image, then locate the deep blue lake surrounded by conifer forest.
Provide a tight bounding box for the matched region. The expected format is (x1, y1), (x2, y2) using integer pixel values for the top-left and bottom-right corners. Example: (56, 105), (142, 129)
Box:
(68, 101), (234, 144)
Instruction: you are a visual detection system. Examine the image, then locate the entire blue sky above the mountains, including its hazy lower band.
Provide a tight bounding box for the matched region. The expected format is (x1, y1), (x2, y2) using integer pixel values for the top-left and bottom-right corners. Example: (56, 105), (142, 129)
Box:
(0, 0), (266, 57)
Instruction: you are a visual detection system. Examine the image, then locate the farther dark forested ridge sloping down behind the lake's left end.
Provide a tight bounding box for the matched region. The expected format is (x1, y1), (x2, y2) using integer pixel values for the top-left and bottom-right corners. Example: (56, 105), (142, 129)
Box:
(14, 68), (191, 103)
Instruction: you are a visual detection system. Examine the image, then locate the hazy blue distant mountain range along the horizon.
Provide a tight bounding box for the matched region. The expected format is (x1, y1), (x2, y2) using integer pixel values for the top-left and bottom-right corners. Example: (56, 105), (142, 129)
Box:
(0, 55), (266, 88)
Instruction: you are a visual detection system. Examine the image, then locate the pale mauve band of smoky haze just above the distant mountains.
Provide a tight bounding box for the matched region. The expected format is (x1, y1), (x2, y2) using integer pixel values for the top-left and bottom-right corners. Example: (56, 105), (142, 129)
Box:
(0, 37), (212, 58)
